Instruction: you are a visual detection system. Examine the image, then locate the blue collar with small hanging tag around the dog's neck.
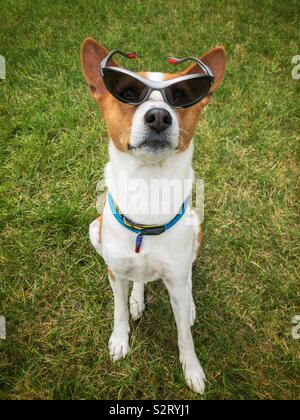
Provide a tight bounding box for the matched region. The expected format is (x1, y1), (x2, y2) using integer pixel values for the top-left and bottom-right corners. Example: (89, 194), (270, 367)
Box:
(108, 193), (189, 254)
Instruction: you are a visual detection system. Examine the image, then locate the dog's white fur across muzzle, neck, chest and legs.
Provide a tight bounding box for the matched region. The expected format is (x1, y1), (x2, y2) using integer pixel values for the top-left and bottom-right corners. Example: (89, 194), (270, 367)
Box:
(90, 79), (205, 394)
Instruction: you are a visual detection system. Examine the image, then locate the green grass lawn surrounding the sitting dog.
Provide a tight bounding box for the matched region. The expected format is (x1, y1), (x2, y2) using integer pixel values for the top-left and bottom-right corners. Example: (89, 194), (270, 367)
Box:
(0, 0), (300, 399)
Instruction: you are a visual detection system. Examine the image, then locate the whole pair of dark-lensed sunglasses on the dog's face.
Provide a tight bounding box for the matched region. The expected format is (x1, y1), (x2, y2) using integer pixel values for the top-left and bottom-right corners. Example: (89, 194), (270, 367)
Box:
(100, 50), (215, 108)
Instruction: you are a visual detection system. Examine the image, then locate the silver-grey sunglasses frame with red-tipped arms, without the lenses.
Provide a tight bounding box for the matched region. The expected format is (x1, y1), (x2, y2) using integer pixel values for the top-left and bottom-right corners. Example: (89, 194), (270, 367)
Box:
(100, 50), (215, 109)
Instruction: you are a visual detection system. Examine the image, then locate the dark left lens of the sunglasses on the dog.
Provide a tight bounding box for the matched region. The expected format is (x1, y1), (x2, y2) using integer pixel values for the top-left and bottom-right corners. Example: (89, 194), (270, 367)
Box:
(103, 69), (148, 103)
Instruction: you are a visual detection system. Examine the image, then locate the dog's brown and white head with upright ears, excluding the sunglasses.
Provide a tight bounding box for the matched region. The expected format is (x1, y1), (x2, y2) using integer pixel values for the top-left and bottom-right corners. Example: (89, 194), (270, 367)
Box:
(81, 38), (226, 162)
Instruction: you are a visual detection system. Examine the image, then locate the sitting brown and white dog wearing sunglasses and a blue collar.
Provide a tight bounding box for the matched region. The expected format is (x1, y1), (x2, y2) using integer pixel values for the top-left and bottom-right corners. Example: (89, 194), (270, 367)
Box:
(81, 38), (226, 394)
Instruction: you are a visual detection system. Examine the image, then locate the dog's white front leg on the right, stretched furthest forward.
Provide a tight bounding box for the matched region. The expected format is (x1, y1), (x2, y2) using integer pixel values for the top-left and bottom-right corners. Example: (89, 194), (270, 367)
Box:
(164, 275), (205, 394)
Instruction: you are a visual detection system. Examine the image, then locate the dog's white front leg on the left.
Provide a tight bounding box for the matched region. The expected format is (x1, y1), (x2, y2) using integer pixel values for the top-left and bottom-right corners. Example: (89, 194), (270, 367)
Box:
(109, 273), (130, 362)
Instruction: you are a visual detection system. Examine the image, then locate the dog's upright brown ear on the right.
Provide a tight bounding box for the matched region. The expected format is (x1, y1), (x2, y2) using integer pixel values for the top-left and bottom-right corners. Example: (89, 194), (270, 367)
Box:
(186, 47), (226, 106)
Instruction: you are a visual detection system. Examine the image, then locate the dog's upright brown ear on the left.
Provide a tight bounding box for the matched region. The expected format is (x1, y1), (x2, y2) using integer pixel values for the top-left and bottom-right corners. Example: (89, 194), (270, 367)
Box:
(80, 38), (118, 100)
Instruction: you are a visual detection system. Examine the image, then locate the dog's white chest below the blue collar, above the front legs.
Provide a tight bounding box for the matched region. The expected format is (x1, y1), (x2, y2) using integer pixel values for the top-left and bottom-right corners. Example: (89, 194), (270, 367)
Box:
(102, 205), (195, 281)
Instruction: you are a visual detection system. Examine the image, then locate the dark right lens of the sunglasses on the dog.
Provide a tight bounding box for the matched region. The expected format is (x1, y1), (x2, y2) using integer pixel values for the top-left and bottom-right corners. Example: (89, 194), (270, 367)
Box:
(166, 77), (211, 107)
